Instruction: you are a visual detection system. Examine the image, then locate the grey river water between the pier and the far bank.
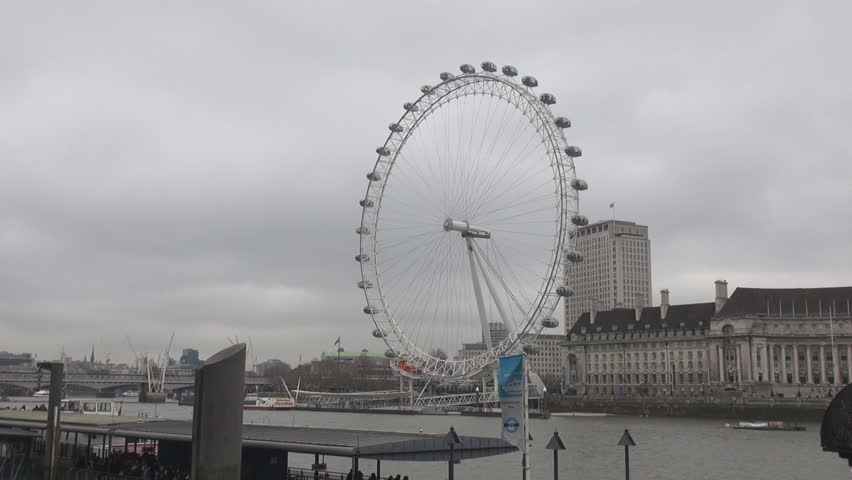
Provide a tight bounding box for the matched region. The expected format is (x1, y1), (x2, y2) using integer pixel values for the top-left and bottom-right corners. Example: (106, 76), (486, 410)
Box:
(0, 399), (849, 480)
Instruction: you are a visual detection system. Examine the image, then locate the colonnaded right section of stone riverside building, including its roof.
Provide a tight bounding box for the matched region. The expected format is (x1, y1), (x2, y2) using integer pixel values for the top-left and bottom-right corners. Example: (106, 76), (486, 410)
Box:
(707, 287), (852, 397)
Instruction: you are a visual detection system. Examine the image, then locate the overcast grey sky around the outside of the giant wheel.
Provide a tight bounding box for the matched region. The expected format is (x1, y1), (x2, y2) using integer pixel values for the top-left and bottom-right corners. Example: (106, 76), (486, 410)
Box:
(0, 0), (852, 363)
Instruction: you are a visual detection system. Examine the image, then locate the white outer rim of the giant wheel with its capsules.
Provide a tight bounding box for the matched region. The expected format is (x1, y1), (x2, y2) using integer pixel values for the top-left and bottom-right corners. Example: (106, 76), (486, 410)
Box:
(356, 67), (584, 379)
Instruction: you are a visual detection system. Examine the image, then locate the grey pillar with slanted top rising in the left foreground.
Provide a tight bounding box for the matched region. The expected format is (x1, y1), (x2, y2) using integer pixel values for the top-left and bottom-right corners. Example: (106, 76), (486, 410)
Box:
(192, 343), (246, 480)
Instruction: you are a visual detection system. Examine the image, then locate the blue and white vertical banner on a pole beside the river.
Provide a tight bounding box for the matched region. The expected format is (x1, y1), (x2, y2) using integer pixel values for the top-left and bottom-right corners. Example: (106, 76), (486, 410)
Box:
(497, 355), (527, 451)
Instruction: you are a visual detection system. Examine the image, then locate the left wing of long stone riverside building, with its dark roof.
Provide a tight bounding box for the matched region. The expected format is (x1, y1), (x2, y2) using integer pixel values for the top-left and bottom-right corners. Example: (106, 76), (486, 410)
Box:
(562, 284), (716, 395)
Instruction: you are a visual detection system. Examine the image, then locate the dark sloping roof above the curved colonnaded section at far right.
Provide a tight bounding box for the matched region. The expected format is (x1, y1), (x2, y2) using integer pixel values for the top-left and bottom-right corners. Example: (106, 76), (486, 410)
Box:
(718, 287), (852, 317)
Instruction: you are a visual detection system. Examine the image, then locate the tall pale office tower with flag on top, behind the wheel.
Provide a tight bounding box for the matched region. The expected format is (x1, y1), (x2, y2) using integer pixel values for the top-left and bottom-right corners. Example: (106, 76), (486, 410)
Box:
(565, 220), (651, 332)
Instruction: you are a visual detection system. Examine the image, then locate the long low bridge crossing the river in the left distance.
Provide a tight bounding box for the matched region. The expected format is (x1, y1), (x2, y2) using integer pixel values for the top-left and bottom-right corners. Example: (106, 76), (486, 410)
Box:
(0, 371), (275, 392)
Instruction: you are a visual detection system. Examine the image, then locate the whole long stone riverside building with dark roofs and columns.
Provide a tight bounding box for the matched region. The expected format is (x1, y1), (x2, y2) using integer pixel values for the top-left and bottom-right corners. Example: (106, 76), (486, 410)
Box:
(562, 281), (852, 397)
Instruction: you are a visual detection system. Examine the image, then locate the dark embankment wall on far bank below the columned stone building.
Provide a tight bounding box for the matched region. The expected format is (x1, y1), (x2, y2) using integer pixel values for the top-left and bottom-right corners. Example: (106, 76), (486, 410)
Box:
(550, 397), (828, 422)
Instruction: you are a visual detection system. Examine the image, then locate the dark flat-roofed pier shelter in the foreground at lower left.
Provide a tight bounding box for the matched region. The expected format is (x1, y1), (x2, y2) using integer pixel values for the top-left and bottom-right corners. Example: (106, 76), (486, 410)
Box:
(0, 411), (516, 478)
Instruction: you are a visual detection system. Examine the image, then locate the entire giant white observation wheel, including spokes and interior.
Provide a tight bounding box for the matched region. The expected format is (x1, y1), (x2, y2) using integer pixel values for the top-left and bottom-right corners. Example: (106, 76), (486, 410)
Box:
(356, 62), (588, 378)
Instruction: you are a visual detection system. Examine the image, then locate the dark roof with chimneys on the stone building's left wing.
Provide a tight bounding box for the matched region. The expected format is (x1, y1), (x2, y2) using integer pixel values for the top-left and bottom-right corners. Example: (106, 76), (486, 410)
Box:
(568, 302), (716, 339)
